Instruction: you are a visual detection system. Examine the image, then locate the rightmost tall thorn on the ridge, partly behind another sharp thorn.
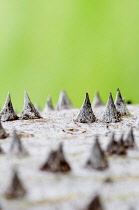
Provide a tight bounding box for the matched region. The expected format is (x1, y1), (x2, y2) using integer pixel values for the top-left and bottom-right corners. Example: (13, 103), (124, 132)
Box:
(115, 88), (130, 116)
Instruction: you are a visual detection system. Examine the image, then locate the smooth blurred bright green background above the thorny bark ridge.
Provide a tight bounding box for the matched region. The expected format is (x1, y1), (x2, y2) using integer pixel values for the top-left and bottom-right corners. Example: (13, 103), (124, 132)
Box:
(0, 0), (139, 111)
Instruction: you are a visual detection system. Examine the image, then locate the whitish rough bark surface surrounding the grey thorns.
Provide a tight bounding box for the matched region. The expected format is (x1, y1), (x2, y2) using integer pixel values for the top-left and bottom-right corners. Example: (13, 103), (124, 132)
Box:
(0, 105), (139, 210)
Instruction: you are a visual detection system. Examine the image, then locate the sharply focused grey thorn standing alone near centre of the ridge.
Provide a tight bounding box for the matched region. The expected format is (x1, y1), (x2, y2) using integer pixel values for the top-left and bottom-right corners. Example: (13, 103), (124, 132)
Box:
(74, 93), (96, 123)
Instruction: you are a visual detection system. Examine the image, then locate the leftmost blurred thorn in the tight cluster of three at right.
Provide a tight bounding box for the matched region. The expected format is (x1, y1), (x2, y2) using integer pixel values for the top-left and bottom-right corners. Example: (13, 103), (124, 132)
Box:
(106, 133), (118, 155)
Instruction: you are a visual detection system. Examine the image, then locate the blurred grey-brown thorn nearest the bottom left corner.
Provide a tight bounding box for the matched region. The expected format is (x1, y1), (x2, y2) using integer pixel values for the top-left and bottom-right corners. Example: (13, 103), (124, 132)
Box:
(5, 169), (26, 199)
